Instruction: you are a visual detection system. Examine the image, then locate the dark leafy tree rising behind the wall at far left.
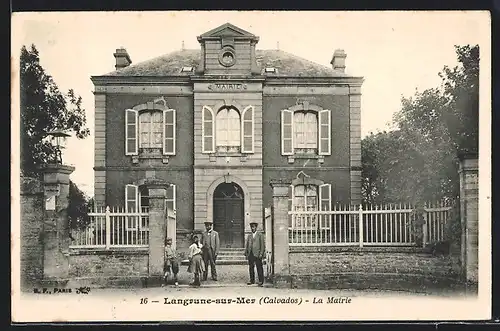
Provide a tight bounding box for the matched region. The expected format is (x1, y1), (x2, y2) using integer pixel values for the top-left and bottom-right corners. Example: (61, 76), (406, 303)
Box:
(20, 45), (90, 176)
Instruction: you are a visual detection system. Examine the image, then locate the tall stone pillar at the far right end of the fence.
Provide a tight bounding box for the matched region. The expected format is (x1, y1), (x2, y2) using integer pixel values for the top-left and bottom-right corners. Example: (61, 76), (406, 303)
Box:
(459, 154), (479, 284)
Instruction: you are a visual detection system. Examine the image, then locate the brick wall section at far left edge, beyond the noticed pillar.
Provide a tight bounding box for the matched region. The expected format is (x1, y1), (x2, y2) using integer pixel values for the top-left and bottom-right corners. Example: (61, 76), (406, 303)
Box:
(20, 177), (44, 288)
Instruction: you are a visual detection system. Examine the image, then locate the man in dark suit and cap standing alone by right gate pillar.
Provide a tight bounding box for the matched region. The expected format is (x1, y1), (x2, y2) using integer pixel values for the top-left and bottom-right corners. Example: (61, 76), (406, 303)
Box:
(245, 222), (266, 286)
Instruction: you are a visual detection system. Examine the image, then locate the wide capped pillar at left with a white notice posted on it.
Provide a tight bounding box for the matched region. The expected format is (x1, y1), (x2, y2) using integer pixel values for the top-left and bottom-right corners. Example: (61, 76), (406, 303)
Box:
(40, 164), (75, 285)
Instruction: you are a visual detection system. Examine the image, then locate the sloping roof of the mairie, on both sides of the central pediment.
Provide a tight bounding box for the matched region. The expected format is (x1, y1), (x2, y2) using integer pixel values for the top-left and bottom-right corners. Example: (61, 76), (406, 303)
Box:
(104, 49), (349, 77)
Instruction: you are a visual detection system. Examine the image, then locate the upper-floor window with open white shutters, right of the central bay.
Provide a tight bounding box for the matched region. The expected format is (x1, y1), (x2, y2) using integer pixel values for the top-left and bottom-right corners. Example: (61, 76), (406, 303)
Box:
(281, 107), (331, 155)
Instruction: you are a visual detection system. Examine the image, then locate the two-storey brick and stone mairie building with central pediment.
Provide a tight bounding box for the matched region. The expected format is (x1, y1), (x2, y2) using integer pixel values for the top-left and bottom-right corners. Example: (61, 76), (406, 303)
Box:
(91, 23), (363, 252)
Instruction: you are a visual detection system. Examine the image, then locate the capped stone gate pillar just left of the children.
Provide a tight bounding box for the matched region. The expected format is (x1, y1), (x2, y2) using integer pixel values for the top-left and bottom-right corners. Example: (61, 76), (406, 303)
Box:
(144, 178), (170, 284)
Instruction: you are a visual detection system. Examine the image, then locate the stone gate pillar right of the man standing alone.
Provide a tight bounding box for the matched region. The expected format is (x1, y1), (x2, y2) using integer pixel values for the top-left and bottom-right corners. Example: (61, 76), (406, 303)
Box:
(270, 180), (291, 288)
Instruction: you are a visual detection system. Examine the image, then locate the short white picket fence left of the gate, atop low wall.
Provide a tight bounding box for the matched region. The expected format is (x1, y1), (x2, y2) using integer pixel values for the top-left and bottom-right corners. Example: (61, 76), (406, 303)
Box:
(70, 207), (149, 249)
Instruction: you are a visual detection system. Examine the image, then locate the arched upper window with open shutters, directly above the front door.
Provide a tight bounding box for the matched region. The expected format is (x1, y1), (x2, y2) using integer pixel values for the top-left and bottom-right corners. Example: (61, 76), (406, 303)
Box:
(201, 106), (255, 153)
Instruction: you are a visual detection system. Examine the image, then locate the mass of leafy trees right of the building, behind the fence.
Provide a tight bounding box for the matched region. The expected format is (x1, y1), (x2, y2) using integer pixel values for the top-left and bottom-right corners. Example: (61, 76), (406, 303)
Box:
(361, 45), (479, 203)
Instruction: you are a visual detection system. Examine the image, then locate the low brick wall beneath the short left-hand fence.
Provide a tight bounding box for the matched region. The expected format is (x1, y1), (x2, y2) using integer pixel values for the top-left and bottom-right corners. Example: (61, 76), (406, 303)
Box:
(68, 248), (149, 287)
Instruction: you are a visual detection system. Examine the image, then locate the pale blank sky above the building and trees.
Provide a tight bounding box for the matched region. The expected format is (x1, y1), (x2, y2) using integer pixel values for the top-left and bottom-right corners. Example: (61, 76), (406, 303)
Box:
(12, 11), (490, 196)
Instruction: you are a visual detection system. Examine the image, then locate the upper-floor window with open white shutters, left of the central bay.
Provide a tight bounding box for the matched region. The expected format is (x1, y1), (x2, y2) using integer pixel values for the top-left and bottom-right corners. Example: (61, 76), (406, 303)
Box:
(125, 109), (176, 155)
